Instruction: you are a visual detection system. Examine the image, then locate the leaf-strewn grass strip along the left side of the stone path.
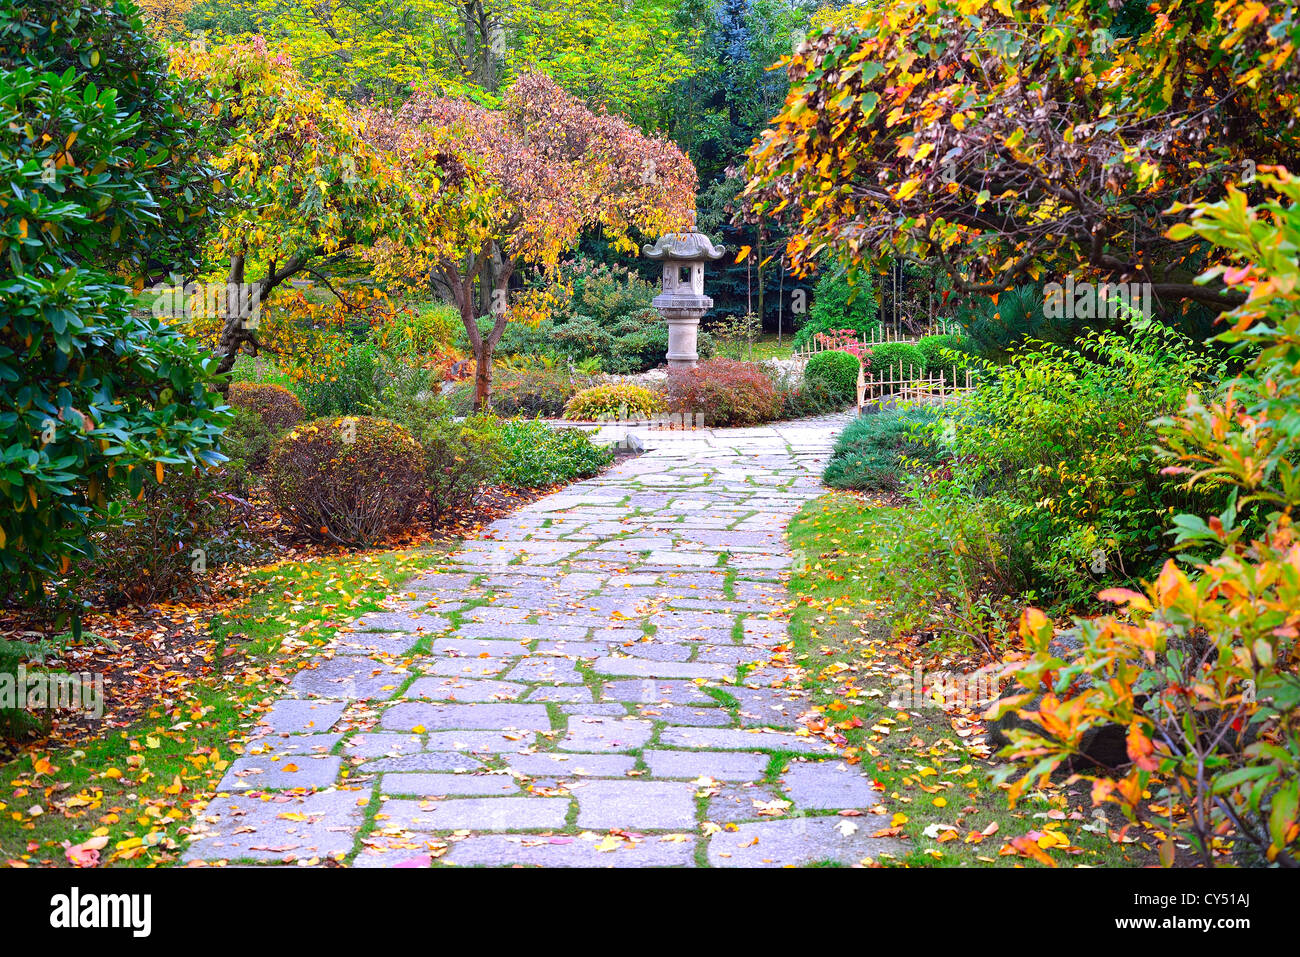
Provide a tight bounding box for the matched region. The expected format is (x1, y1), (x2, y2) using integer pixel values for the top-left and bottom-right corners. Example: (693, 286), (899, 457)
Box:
(0, 547), (445, 867)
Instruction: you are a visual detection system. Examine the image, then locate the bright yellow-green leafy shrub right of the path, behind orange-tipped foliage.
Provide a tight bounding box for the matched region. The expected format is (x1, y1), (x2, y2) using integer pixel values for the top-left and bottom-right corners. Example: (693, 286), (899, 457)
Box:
(926, 322), (1210, 602)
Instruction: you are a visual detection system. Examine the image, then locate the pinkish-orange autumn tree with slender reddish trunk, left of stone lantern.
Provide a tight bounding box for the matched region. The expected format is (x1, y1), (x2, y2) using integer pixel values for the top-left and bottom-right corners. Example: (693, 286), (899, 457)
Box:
(367, 74), (696, 408)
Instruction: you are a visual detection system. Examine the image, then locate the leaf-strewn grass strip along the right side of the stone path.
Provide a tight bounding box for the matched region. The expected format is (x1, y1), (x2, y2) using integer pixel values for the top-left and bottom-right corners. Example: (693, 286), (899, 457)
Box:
(789, 493), (1153, 867)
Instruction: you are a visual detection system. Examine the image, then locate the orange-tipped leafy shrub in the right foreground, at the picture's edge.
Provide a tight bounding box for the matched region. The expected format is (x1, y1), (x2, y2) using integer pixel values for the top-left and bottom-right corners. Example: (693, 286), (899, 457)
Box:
(1000, 168), (1300, 867)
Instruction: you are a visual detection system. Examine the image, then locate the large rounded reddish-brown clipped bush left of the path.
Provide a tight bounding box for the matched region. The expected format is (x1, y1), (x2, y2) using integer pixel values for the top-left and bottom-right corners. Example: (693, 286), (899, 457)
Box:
(267, 416), (426, 545)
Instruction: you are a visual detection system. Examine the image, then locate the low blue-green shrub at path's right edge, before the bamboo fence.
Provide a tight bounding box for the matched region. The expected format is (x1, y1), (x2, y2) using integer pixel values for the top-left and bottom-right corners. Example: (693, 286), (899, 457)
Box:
(822, 406), (944, 492)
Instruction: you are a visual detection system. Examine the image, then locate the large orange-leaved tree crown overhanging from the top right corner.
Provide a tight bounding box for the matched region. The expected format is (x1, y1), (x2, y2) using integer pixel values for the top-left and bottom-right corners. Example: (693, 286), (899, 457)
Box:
(746, 0), (1300, 309)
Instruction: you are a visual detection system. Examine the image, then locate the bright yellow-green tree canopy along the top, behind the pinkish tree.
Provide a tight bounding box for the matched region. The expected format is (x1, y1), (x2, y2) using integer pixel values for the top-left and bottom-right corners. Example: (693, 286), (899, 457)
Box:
(187, 0), (693, 126)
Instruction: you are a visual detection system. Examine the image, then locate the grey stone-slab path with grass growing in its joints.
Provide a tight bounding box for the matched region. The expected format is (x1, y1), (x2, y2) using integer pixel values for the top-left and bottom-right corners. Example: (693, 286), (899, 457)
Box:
(185, 417), (906, 867)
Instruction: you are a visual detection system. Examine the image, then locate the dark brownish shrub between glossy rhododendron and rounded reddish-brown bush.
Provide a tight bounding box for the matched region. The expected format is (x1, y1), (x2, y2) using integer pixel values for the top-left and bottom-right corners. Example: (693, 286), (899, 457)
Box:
(81, 467), (251, 606)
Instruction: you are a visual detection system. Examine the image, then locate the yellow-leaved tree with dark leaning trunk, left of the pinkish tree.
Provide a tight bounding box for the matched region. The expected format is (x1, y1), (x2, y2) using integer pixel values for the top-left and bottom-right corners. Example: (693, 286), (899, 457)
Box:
(173, 38), (406, 382)
